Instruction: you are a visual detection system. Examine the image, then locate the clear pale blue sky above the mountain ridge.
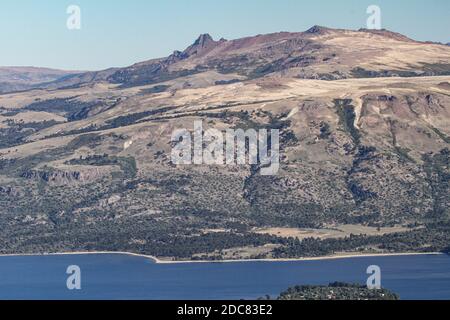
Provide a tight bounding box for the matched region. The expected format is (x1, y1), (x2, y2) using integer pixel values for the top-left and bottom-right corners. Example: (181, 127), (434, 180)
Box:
(0, 0), (450, 70)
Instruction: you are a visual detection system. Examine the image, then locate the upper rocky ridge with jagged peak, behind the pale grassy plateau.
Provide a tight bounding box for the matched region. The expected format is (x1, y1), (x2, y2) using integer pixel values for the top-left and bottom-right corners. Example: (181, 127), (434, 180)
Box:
(22, 26), (450, 92)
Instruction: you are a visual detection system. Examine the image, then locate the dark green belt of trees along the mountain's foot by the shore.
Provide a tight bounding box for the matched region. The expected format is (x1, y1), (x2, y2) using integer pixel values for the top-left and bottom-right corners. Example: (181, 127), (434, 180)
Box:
(1, 222), (450, 260)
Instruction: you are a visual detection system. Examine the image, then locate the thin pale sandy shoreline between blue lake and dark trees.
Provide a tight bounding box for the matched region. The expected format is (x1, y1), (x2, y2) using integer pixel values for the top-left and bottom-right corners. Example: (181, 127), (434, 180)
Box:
(0, 251), (445, 264)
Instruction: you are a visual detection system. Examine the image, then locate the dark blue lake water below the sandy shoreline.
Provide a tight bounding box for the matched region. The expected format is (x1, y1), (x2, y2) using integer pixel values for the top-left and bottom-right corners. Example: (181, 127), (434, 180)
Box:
(0, 254), (450, 300)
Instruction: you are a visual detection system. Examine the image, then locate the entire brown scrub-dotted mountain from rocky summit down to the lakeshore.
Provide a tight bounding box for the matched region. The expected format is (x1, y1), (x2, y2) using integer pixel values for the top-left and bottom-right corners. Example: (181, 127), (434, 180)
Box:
(0, 26), (450, 259)
